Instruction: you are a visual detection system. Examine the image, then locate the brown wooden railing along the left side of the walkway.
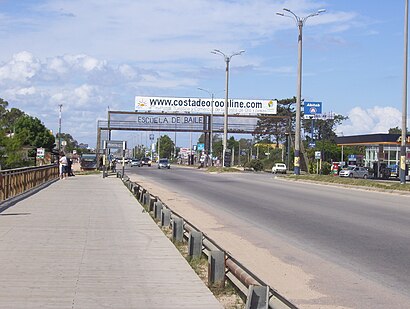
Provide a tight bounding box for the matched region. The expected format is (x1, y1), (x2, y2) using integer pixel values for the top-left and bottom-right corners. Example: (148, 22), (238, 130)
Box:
(0, 164), (59, 203)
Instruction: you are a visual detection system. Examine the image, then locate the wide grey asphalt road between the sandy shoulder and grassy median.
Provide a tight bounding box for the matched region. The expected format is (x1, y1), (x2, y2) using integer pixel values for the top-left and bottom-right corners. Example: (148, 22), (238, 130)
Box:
(127, 167), (410, 308)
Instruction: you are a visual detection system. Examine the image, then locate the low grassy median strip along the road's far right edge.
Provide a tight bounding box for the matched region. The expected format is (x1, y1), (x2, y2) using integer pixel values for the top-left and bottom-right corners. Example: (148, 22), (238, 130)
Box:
(287, 175), (410, 192)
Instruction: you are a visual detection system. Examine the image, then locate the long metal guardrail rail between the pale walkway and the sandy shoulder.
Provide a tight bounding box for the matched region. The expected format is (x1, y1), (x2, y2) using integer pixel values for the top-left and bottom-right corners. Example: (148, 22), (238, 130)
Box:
(117, 173), (298, 309)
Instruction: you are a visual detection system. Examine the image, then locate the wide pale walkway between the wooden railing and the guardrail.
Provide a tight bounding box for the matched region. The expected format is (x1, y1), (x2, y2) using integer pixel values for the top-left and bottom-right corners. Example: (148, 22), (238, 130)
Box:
(0, 175), (222, 309)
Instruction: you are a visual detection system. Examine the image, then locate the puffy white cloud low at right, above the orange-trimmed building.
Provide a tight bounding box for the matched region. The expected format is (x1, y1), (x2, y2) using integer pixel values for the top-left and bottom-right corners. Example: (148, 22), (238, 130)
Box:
(336, 106), (401, 136)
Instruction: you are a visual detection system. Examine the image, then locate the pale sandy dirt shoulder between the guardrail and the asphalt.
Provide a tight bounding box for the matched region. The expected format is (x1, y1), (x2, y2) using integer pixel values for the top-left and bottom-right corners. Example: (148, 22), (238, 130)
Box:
(130, 175), (334, 309)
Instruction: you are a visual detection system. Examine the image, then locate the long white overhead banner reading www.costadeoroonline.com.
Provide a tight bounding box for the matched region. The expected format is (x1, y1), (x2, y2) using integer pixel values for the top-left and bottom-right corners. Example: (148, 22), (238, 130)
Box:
(135, 96), (278, 115)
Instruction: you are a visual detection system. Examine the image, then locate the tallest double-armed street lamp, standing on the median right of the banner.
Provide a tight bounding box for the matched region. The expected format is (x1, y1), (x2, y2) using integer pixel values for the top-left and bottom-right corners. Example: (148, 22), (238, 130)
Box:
(276, 8), (326, 175)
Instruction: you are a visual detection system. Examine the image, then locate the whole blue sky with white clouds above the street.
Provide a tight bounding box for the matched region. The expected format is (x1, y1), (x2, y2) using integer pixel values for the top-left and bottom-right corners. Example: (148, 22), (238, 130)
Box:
(0, 0), (409, 147)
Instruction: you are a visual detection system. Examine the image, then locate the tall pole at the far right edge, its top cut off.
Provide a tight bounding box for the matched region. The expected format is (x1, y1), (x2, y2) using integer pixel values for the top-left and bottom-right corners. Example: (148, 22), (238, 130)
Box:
(400, 0), (409, 184)
